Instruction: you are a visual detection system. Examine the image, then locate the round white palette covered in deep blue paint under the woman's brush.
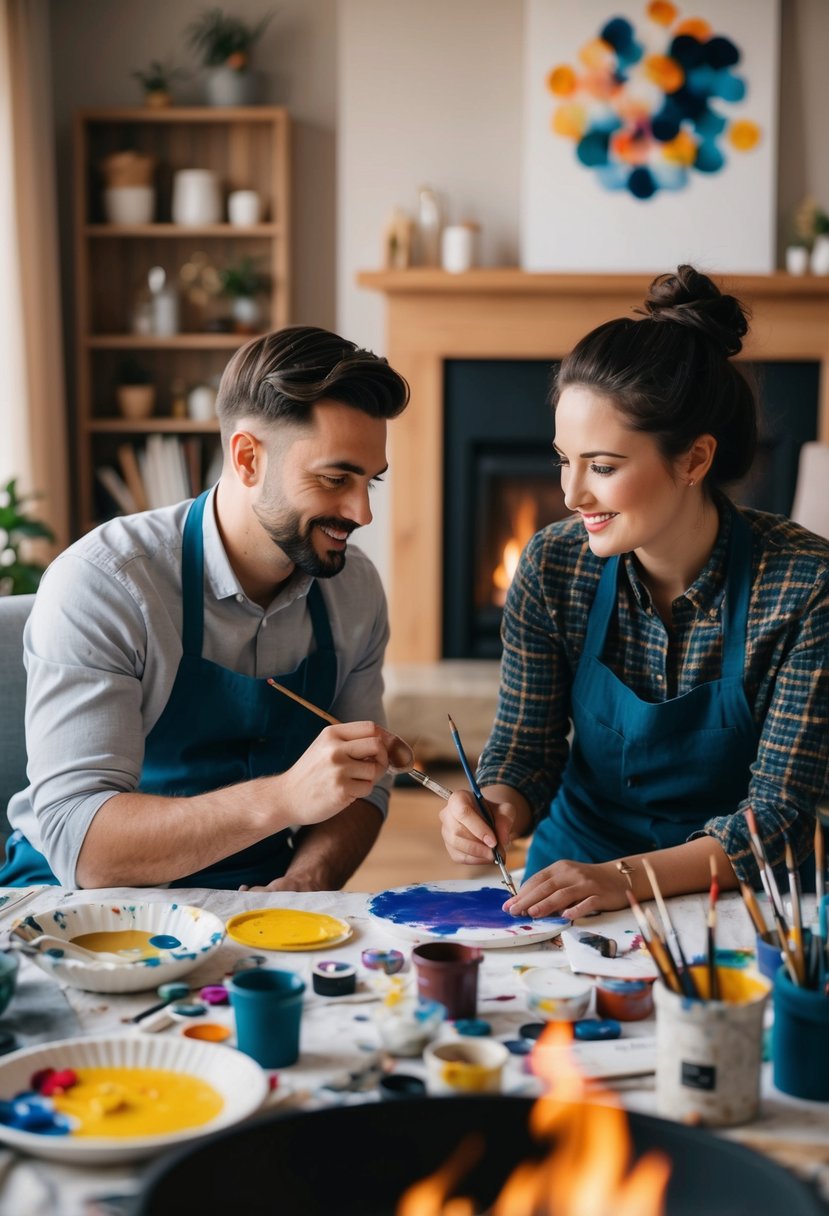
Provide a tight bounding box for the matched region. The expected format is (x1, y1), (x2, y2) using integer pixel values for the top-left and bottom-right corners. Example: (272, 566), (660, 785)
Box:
(368, 879), (570, 948)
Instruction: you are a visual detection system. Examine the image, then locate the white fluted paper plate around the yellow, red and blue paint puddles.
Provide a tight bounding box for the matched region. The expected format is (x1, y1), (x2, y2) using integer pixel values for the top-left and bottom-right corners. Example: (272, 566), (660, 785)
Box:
(0, 1034), (267, 1165)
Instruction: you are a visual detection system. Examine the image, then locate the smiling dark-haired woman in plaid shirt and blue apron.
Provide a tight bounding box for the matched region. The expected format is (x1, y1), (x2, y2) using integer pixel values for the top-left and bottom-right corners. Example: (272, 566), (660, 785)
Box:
(441, 266), (829, 918)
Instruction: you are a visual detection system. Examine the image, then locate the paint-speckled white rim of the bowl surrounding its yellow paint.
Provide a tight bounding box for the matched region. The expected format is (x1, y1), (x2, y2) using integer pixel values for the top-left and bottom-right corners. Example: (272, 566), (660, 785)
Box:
(11, 901), (225, 992)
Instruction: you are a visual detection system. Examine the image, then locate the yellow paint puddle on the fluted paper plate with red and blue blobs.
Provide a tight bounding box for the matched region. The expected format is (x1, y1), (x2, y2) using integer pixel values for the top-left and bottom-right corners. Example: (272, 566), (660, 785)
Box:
(53, 1068), (225, 1138)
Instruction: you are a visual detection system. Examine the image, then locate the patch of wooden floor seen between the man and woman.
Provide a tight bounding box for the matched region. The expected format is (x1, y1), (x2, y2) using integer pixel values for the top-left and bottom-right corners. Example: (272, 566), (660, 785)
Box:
(345, 769), (523, 891)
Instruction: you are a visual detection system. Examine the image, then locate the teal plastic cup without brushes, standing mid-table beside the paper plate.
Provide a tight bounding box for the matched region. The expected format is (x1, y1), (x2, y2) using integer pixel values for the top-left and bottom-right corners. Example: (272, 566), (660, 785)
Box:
(227, 967), (305, 1068)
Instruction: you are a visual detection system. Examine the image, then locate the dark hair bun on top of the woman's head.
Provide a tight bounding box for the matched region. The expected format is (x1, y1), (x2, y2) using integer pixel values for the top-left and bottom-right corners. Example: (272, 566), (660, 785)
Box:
(637, 266), (749, 355)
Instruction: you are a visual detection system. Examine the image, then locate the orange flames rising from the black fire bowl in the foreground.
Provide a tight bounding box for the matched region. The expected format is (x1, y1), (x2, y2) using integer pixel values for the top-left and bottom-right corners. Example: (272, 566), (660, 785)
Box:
(396, 1021), (671, 1216)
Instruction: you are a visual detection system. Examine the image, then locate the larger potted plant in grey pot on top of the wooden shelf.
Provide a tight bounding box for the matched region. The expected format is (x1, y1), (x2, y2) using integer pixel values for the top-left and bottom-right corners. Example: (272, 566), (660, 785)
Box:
(188, 9), (273, 106)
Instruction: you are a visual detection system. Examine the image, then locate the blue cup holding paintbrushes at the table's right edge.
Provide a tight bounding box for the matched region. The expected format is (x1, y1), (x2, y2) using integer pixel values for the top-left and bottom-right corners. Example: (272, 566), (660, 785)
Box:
(772, 968), (829, 1102)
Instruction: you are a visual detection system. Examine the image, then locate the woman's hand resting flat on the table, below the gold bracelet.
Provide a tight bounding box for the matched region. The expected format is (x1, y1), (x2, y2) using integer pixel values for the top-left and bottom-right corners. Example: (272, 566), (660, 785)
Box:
(503, 861), (627, 921)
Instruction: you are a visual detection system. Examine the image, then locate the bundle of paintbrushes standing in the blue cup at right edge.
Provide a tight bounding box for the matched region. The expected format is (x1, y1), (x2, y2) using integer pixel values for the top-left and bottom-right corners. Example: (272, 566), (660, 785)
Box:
(740, 806), (829, 993)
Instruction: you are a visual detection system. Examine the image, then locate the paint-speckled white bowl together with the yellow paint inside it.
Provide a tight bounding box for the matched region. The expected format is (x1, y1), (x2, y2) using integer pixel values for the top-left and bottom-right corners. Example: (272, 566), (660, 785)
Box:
(10, 901), (225, 992)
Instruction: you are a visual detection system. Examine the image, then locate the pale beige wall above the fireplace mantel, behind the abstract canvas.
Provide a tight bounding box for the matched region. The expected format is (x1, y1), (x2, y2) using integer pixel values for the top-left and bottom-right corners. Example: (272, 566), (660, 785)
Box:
(337, 0), (829, 576)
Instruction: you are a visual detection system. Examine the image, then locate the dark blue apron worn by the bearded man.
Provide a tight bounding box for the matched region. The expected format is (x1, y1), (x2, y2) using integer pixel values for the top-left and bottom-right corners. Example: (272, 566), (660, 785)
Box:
(0, 494), (337, 888)
